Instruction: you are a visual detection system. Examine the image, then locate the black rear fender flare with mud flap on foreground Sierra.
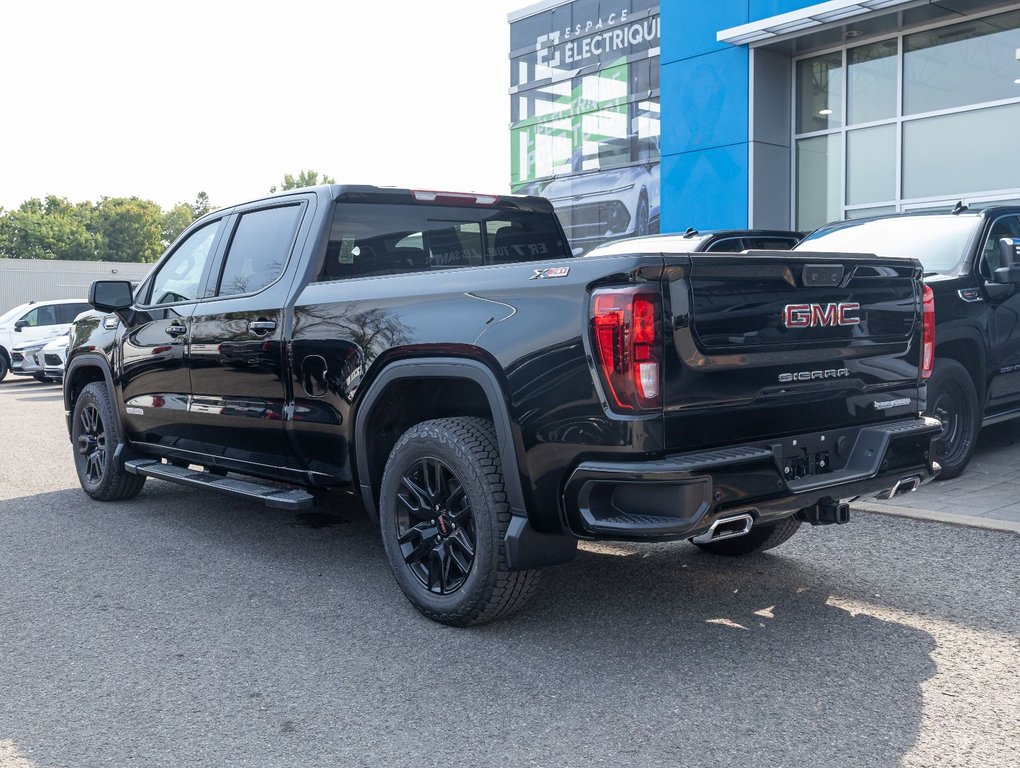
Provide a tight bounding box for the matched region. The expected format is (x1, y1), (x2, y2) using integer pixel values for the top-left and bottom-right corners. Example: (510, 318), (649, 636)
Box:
(354, 357), (577, 570)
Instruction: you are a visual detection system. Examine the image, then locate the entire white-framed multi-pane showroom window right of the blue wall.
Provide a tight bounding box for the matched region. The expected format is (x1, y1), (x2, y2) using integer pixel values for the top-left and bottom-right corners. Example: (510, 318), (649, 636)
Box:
(794, 10), (1020, 229)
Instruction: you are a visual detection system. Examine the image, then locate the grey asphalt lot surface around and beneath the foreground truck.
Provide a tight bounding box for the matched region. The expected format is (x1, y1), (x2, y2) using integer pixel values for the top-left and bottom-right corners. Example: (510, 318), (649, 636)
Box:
(0, 380), (1020, 768)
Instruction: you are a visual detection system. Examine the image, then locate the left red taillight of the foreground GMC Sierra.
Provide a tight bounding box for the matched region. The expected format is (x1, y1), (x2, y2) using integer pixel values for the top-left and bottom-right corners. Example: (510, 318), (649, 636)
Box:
(592, 287), (662, 412)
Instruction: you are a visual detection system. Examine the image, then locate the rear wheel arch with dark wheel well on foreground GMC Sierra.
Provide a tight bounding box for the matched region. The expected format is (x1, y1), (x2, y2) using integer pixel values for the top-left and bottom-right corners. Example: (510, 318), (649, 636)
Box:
(354, 358), (527, 521)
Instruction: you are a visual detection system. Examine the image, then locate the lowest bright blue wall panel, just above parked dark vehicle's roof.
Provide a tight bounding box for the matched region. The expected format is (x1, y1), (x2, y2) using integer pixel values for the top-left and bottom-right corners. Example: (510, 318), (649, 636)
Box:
(661, 144), (748, 227)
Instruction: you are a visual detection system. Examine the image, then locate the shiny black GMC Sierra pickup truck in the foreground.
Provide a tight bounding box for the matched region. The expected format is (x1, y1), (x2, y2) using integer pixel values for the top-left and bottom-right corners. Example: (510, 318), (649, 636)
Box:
(64, 186), (939, 625)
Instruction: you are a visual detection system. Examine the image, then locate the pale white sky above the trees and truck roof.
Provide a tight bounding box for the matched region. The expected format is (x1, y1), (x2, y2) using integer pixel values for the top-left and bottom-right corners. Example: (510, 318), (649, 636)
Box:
(0, 0), (531, 208)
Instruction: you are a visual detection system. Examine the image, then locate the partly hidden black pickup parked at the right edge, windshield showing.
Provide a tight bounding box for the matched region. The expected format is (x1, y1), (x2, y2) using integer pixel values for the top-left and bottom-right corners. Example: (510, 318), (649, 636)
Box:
(797, 204), (1020, 479)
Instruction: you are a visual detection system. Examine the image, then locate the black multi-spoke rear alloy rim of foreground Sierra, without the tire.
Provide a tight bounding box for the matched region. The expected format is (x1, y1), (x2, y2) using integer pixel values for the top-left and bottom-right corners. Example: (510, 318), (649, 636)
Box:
(396, 456), (475, 595)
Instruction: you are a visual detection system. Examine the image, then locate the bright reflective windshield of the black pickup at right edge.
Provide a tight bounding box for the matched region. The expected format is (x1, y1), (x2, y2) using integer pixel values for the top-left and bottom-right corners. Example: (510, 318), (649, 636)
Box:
(794, 215), (980, 274)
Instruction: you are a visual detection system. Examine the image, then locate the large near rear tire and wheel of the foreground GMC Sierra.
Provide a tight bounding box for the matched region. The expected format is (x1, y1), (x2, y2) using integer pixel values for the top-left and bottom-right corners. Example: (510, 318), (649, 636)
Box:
(379, 417), (539, 626)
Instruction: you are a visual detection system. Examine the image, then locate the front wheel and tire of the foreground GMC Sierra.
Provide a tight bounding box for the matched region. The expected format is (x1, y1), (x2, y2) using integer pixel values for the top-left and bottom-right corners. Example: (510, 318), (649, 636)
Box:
(70, 381), (145, 502)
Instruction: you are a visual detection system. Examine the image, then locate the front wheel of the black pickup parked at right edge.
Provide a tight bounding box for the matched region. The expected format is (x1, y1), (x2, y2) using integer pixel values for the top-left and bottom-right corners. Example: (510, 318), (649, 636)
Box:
(928, 360), (981, 480)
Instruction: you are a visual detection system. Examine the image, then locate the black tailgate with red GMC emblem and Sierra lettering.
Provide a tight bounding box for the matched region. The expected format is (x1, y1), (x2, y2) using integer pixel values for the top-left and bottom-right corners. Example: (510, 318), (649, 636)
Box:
(663, 251), (922, 450)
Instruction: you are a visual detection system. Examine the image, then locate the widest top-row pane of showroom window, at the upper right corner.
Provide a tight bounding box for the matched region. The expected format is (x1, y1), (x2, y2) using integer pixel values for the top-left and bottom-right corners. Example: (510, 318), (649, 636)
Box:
(903, 11), (1020, 114)
